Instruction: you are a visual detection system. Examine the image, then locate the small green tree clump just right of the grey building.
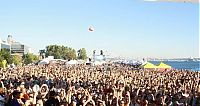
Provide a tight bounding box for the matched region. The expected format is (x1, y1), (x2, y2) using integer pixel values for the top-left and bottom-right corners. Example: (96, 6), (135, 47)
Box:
(23, 53), (38, 64)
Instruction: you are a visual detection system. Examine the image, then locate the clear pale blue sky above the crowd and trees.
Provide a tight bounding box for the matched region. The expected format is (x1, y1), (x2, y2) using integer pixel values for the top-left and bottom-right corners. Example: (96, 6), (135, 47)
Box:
(0, 0), (199, 58)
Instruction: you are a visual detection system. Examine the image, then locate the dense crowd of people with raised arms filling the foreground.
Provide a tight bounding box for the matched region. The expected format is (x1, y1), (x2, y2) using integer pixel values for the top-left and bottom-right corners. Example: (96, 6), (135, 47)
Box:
(0, 64), (200, 106)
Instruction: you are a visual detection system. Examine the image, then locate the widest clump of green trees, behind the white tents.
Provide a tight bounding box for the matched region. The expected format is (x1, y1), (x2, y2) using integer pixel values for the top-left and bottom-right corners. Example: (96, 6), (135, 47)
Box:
(46, 45), (76, 60)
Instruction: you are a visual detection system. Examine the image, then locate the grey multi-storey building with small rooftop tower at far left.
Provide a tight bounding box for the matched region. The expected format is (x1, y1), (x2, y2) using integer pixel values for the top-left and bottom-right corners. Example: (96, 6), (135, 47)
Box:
(7, 35), (31, 56)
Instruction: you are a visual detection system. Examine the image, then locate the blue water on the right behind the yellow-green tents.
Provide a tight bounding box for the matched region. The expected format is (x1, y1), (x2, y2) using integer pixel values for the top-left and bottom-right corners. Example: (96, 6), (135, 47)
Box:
(151, 61), (200, 71)
